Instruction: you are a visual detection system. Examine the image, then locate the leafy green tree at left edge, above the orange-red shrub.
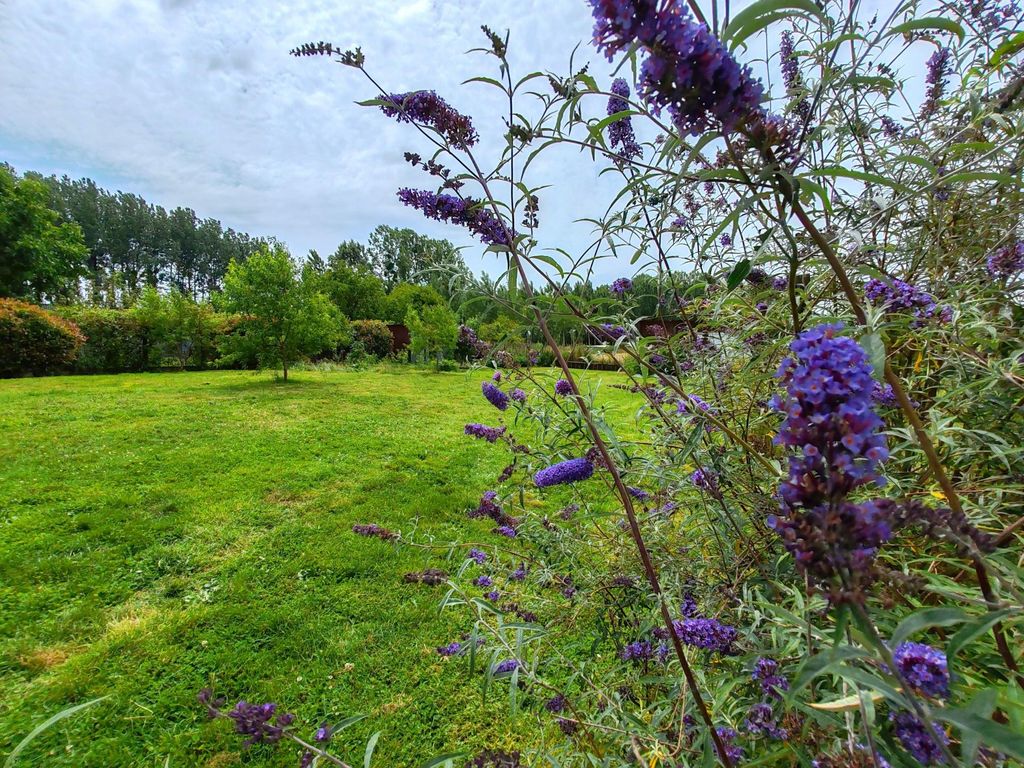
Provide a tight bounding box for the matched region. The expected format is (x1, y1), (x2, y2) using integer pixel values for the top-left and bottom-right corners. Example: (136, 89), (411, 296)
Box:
(0, 166), (88, 303)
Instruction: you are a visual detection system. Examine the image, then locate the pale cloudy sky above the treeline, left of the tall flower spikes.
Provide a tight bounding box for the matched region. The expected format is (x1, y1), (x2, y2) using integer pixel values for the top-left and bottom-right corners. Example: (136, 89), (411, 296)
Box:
(0, 0), (647, 276)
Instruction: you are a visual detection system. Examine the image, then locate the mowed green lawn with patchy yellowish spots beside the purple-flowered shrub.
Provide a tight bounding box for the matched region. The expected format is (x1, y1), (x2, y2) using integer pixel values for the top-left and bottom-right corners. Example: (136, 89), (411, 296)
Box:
(0, 369), (622, 767)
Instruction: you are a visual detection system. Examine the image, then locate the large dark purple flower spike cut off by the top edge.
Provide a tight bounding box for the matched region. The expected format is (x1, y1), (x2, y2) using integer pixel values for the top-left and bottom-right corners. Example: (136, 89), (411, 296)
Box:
(590, 0), (762, 136)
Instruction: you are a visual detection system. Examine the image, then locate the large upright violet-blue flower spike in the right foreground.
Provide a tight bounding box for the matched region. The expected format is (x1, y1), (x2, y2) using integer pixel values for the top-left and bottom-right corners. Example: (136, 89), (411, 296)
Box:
(768, 325), (891, 597)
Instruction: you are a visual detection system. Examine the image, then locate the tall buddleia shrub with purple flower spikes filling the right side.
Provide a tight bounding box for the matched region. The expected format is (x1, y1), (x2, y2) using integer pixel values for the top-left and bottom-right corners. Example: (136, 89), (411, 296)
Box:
(203, 0), (1024, 768)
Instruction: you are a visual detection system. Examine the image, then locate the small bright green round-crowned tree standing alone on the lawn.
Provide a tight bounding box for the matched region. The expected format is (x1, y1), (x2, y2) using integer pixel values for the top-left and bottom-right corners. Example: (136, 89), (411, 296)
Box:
(223, 245), (341, 381)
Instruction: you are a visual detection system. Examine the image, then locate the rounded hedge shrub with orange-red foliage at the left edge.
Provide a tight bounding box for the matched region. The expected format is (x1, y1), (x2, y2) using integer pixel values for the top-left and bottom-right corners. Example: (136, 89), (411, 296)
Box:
(0, 299), (85, 376)
